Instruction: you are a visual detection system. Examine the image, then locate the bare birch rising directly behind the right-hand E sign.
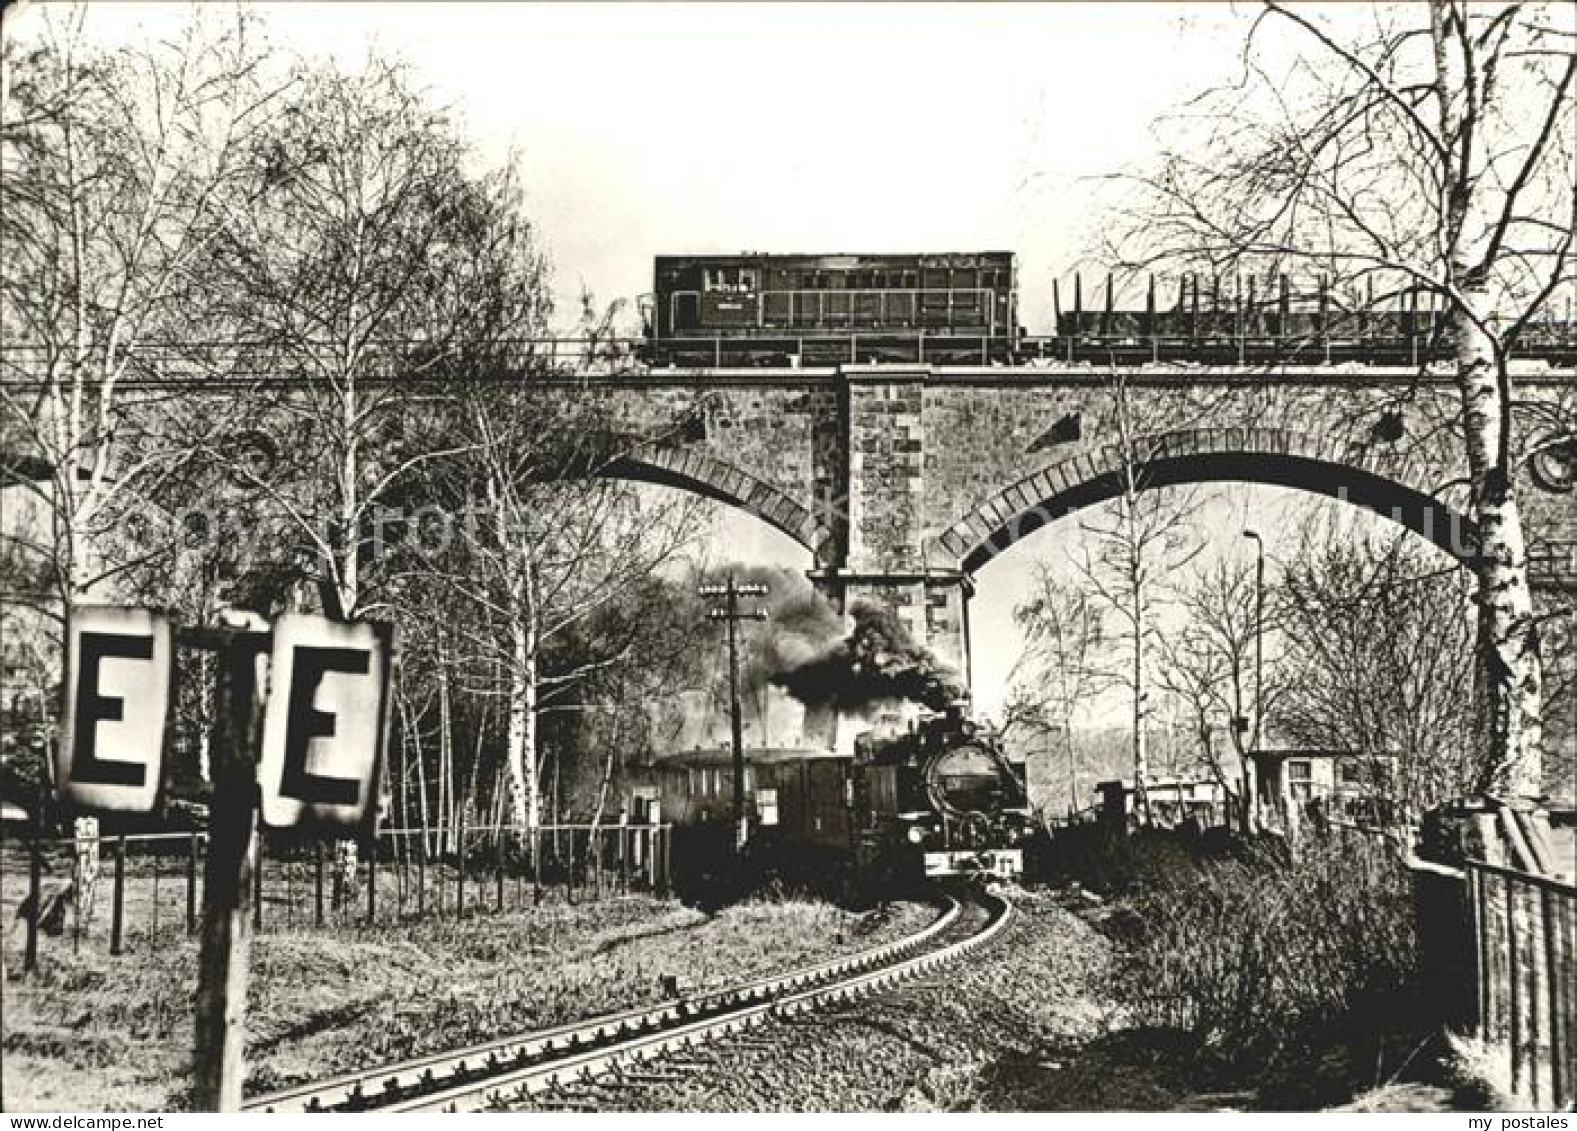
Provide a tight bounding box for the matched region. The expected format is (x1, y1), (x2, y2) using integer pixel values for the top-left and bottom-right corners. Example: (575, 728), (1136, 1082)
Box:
(203, 55), (550, 893)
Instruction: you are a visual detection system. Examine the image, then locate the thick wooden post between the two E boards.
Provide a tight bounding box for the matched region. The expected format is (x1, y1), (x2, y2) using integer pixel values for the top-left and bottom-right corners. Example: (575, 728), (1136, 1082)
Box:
(192, 633), (268, 1112)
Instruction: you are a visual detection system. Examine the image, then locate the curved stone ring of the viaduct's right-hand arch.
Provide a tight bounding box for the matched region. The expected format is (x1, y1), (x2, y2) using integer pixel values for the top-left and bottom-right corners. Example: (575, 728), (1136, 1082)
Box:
(932, 427), (1478, 573)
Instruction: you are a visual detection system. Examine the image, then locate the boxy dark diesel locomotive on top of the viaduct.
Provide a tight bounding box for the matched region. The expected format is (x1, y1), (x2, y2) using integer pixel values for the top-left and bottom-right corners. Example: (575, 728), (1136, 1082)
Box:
(647, 251), (1022, 366)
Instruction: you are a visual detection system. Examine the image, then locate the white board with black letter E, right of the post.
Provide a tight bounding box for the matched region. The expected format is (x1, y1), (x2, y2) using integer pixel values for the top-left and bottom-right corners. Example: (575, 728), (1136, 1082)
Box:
(257, 614), (394, 830)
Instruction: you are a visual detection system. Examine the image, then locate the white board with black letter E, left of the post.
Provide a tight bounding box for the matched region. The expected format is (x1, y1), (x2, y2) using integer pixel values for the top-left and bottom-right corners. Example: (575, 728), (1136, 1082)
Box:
(55, 604), (175, 812)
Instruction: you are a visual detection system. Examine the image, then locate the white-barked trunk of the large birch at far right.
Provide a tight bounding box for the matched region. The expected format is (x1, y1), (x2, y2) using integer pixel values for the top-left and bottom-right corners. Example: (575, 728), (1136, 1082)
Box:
(1449, 287), (1544, 797)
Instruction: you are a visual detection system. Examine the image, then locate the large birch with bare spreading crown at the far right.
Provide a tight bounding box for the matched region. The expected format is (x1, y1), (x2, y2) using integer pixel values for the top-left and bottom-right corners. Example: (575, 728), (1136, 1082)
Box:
(1121, 0), (1577, 793)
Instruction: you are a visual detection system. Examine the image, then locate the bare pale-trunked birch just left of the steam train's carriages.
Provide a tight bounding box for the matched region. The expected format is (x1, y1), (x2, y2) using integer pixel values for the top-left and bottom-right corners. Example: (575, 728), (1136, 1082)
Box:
(425, 386), (709, 827)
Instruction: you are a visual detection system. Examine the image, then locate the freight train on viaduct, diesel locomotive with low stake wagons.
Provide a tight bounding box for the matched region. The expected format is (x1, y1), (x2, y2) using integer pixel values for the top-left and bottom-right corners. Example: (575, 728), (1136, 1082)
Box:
(642, 251), (1577, 368)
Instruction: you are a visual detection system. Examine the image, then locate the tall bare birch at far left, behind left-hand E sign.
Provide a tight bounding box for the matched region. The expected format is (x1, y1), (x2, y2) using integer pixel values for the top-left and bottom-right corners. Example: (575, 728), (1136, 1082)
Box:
(0, 8), (278, 913)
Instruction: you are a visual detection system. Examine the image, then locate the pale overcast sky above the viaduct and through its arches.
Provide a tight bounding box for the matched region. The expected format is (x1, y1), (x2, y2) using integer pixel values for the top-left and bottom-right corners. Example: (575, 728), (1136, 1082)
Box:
(22, 0), (1419, 722)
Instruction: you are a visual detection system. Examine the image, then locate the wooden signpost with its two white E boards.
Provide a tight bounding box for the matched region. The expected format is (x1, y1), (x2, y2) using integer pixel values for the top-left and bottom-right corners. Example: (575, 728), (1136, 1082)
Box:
(55, 606), (394, 1112)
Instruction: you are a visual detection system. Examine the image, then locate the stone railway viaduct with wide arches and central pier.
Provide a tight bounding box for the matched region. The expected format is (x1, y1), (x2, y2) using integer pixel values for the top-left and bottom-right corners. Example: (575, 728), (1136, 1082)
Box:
(525, 364), (1577, 776)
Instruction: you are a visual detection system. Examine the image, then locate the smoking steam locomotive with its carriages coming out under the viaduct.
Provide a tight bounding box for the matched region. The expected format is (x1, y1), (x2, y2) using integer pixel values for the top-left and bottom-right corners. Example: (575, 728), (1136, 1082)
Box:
(632, 710), (1035, 891)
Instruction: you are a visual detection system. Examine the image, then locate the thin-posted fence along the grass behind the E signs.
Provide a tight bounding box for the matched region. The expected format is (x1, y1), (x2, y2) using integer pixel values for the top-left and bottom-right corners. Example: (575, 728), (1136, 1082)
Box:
(0, 823), (670, 969)
